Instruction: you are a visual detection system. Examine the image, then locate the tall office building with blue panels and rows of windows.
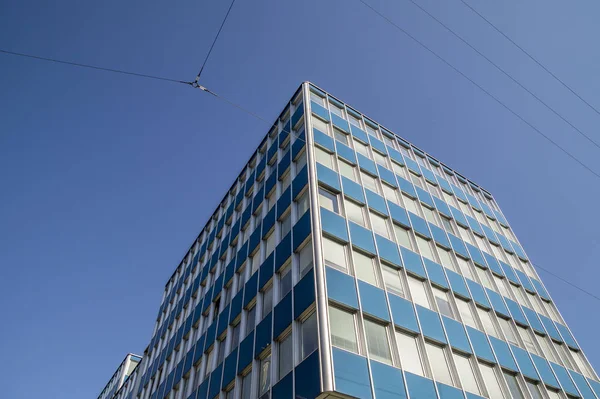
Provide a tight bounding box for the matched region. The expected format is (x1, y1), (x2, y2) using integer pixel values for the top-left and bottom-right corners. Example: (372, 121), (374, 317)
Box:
(102, 83), (600, 399)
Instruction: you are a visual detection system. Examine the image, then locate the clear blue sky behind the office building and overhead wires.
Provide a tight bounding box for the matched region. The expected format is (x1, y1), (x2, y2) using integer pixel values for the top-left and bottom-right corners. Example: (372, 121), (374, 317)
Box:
(0, 0), (600, 399)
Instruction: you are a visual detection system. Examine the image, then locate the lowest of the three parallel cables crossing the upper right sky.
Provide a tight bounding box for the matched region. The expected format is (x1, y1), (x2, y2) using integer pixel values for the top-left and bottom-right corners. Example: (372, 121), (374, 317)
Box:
(358, 0), (600, 179)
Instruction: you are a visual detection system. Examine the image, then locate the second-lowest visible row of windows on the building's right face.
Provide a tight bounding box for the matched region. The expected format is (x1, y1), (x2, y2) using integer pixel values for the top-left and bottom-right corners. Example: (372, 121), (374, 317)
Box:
(323, 237), (594, 377)
